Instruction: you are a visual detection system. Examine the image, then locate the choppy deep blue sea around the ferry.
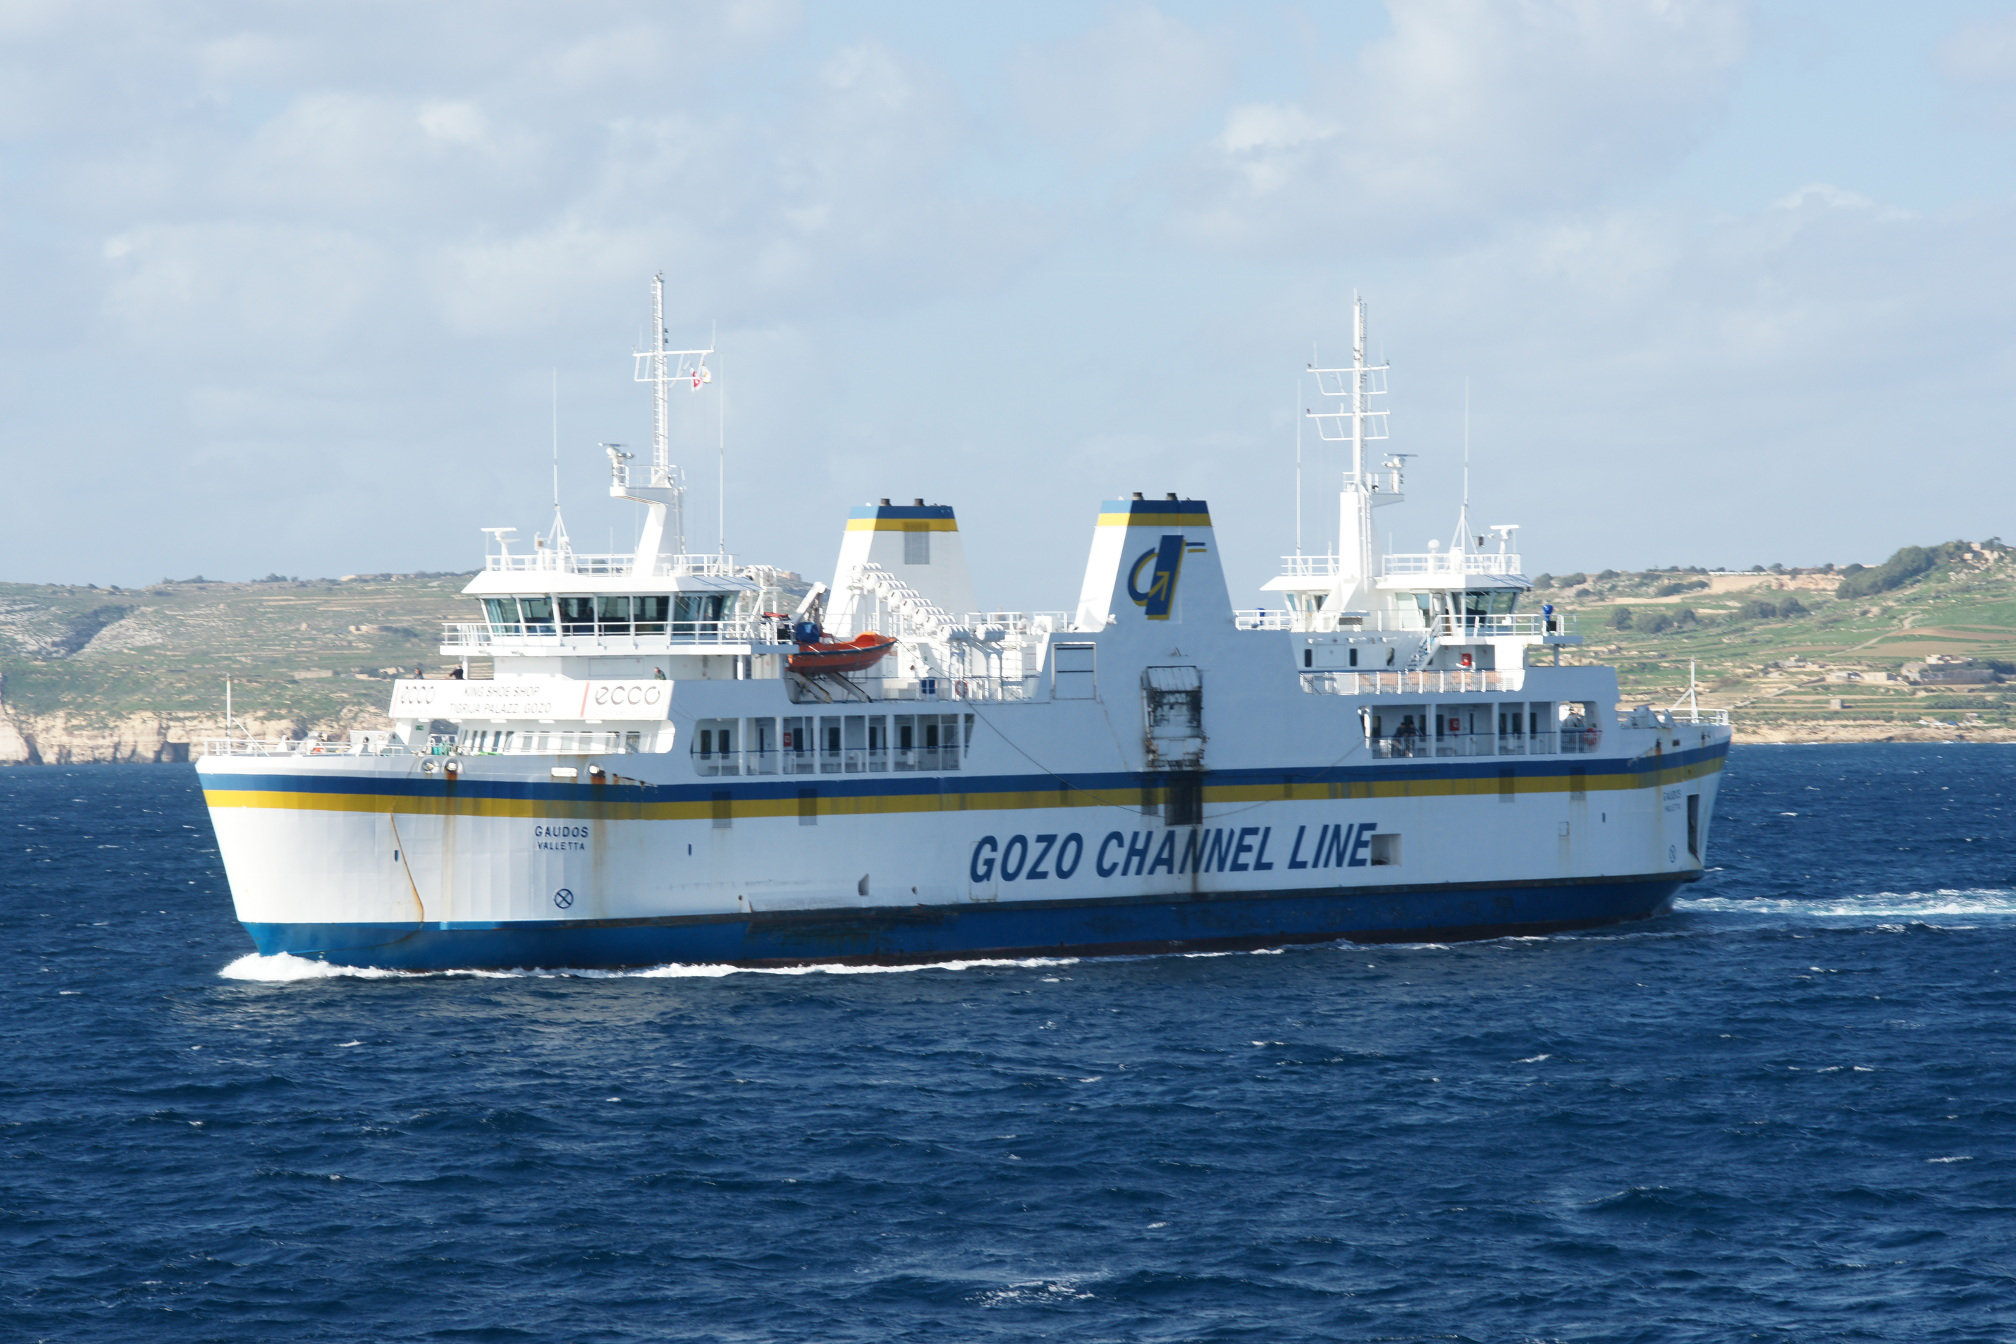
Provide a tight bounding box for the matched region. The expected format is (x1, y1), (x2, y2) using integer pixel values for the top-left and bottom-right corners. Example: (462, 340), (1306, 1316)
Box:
(0, 746), (2016, 1344)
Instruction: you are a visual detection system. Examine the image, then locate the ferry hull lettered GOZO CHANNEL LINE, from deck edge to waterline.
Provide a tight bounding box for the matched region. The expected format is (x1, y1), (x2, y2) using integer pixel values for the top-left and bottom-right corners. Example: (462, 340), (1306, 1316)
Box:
(202, 711), (1728, 969)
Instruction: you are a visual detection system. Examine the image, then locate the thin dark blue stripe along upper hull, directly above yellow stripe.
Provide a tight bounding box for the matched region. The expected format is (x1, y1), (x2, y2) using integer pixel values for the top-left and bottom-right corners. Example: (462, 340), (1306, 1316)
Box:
(200, 744), (1728, 802)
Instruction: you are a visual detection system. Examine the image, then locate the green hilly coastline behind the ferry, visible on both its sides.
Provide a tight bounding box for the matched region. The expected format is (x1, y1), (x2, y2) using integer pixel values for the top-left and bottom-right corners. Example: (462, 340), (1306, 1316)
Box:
(0, 542), (2016, 760)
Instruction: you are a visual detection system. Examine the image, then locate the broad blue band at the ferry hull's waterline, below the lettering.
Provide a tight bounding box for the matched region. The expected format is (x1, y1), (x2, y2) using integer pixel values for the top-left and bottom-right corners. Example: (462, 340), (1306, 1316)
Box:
(246, 872), (1699, 971)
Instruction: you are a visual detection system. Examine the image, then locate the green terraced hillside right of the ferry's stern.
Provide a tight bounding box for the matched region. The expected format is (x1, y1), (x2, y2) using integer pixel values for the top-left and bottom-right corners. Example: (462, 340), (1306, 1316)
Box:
(1536, 540), (2016, 740)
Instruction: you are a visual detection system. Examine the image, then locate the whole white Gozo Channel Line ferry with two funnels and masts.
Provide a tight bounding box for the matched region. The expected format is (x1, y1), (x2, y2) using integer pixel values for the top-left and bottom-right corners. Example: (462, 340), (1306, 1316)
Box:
(198, 278), (1730, 971)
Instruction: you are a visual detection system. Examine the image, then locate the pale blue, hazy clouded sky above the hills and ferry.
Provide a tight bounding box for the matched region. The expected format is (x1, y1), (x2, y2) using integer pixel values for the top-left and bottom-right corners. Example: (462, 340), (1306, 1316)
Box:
(0, 0), (2016, 611)
